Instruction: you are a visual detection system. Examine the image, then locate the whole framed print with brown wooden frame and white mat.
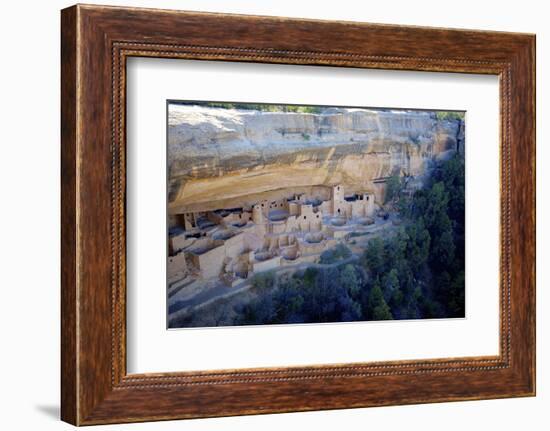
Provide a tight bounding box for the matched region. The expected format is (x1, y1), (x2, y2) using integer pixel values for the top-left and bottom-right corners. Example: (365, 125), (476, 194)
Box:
(61, 5), (535, 425)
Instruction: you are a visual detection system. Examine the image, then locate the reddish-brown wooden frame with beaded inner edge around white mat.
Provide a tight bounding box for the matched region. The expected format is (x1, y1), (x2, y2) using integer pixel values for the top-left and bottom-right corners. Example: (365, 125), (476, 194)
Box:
(62, 6), (535, 424)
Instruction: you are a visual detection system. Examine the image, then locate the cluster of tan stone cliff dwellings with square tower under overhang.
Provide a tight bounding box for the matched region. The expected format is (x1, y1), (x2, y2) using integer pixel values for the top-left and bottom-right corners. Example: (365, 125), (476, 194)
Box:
(168, 185), (375, 285)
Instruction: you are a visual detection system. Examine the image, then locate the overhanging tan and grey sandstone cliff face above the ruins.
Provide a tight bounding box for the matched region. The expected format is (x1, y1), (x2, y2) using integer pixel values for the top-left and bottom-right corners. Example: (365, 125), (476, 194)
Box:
(168, 105), (463, 214)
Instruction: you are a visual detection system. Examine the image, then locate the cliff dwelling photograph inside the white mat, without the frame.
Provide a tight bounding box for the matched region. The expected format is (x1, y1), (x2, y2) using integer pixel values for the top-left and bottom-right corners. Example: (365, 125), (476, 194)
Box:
(166, 100), (465, 329)
